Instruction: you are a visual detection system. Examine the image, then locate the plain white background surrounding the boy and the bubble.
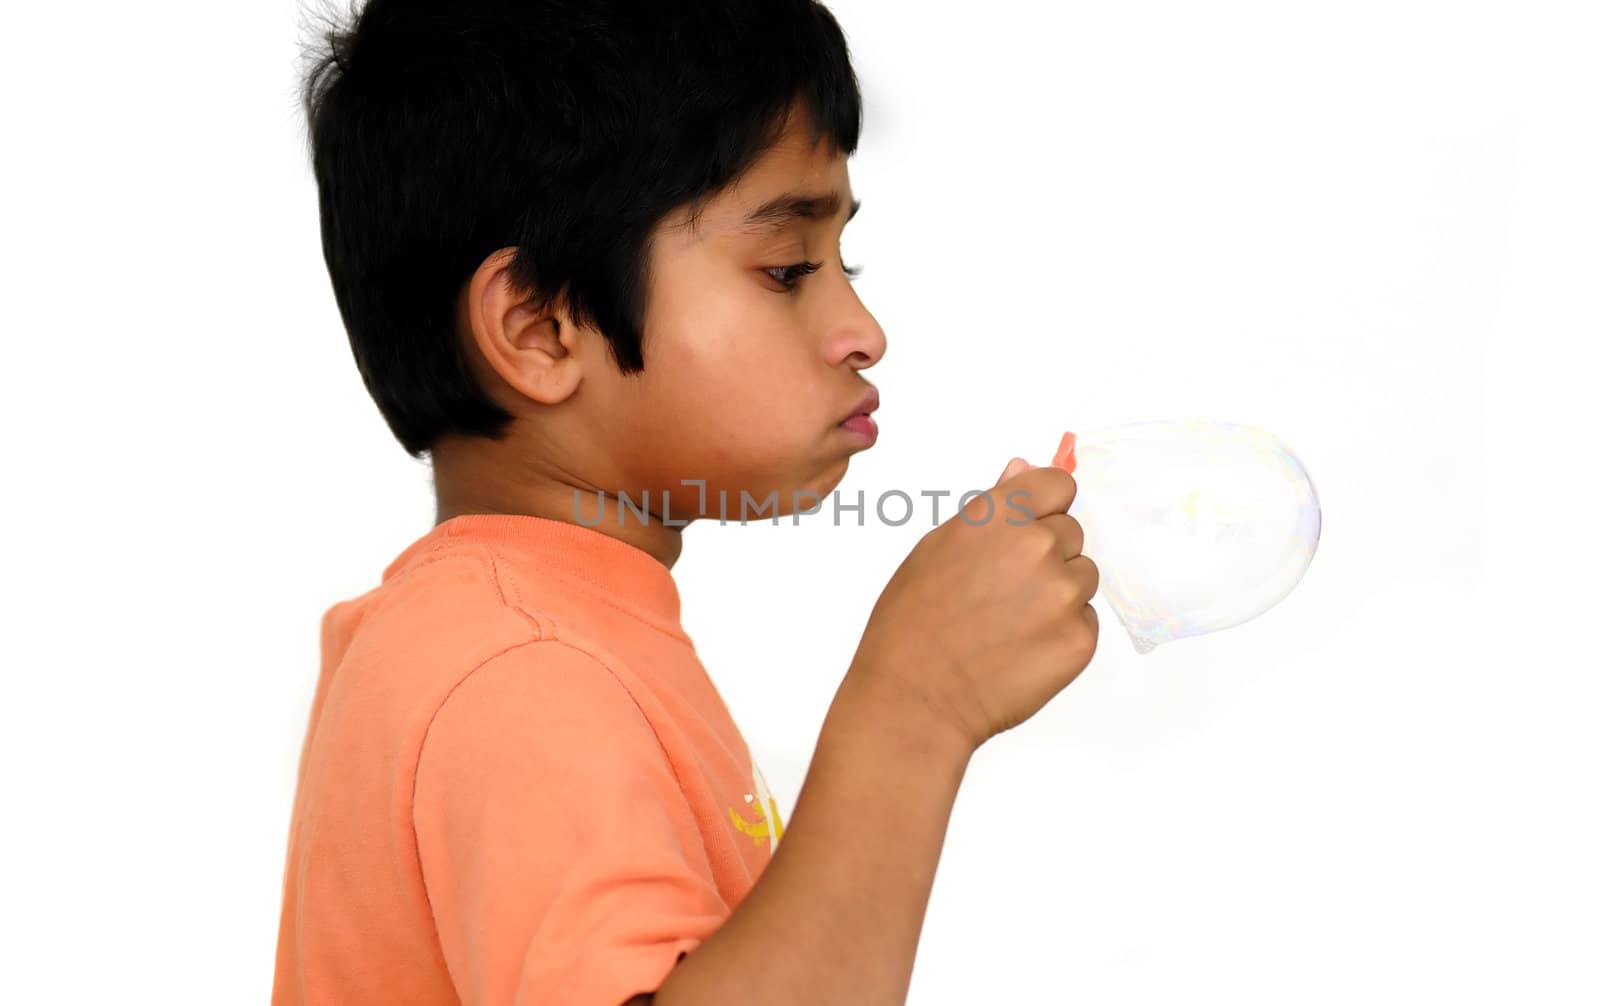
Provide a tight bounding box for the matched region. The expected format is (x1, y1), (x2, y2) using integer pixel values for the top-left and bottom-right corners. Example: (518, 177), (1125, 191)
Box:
(0, 0), (1600, 1006)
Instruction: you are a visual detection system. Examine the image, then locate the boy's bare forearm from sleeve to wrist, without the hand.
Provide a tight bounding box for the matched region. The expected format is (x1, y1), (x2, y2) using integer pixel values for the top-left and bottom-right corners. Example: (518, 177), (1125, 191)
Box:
(654, 675), (971, 1006)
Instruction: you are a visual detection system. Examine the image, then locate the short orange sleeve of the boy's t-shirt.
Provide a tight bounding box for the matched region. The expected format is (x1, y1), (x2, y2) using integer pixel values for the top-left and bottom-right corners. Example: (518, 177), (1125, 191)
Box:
(413, 640), (730, 1006)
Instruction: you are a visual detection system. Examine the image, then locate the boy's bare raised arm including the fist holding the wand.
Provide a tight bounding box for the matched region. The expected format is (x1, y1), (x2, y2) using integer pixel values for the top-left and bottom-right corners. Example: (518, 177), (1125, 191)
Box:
(654, 459), (1099, 1006)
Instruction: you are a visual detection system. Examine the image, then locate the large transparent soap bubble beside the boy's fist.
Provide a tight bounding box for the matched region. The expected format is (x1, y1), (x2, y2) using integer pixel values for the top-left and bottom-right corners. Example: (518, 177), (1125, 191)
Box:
(1053, 419), (1322, 654)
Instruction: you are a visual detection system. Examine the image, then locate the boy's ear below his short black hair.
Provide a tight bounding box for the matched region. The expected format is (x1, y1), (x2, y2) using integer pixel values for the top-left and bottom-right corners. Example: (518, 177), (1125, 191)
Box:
(462, 248), (584, 405)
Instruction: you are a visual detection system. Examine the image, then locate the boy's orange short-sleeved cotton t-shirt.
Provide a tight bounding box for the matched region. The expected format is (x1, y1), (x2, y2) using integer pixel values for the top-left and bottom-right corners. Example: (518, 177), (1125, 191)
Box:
(272, 513), (782, 1006)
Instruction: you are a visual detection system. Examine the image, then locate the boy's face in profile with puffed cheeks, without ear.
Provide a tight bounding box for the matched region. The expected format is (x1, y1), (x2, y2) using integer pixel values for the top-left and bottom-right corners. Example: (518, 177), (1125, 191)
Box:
(563, 109), (885, 520)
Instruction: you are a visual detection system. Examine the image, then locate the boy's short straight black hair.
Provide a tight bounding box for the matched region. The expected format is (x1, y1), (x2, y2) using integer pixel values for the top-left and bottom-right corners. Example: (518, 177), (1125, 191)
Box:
(299, 0), (861, 457)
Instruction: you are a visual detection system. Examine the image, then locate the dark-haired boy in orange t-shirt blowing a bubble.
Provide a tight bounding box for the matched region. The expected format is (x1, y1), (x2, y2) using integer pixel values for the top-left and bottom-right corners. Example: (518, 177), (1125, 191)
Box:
(274, 0), (1099, 1006)
